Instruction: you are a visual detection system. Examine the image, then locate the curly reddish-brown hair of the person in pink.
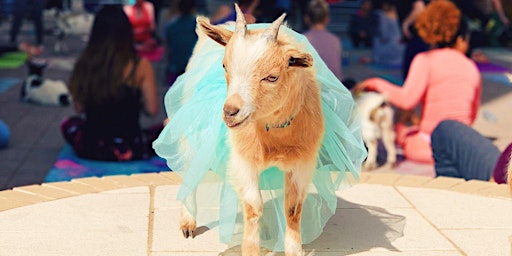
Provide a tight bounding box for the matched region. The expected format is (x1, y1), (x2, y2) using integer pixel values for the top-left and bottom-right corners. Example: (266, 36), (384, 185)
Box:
(415, 0), (462, 46)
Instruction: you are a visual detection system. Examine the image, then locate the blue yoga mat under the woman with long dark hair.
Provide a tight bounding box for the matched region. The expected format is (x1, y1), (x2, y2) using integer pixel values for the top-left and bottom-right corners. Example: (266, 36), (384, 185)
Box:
(44, 144), (169, 182)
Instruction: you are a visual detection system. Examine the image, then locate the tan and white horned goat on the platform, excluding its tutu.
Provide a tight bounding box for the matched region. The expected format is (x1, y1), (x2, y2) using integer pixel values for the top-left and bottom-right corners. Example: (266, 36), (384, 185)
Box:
(180, 4), (324, 256)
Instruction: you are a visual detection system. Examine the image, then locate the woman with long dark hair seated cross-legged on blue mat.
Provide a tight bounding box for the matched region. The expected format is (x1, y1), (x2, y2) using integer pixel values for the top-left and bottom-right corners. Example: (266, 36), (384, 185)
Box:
(61, 5), (163, 161)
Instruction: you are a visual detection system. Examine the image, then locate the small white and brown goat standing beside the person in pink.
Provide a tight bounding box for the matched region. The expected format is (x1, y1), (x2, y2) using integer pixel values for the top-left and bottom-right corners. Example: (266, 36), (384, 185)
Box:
(355, 92), (396, 171)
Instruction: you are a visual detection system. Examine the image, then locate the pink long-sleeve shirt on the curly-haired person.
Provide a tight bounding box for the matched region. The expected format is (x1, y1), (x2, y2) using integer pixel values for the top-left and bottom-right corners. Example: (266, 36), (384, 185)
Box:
(367, 48), (482, 135)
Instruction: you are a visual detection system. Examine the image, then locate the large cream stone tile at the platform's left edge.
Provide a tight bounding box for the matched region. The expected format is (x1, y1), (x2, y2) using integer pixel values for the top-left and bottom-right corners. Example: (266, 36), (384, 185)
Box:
(0, 191), (149, 256)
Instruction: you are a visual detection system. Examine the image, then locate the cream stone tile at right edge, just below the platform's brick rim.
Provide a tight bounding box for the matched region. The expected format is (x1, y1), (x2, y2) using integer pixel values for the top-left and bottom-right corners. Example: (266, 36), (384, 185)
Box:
(398, 187), (512, 229)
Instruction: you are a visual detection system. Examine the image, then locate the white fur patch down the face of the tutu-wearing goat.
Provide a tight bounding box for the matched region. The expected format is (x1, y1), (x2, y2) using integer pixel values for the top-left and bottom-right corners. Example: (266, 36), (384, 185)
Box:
(226, 36), (268, 117)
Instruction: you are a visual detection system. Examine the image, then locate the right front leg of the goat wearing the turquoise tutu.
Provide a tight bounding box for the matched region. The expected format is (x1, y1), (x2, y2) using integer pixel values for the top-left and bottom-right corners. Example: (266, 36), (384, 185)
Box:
(284, 162), (316, 256)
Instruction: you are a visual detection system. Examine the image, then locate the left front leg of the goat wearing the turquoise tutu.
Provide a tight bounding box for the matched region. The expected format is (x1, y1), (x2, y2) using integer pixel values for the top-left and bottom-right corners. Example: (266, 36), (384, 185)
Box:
(229, 154), (263, 256)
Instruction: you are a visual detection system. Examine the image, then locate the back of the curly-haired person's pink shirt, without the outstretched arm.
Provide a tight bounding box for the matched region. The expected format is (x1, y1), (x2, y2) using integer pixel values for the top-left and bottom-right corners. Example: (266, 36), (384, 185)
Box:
(411, 48), (481, 134)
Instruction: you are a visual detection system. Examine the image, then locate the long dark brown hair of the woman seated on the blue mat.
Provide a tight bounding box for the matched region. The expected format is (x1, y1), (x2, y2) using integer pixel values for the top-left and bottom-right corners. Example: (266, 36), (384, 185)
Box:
(69, 5), (137, 106)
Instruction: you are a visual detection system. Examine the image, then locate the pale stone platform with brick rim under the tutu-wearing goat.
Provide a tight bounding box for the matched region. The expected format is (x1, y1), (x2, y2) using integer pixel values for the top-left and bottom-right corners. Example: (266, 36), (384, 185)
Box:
(0, 172), (512, 256)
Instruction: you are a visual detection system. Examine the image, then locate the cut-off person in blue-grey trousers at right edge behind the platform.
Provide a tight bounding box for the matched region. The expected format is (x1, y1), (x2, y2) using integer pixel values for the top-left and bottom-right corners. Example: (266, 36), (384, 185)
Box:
(432, 120), (512, 184)
